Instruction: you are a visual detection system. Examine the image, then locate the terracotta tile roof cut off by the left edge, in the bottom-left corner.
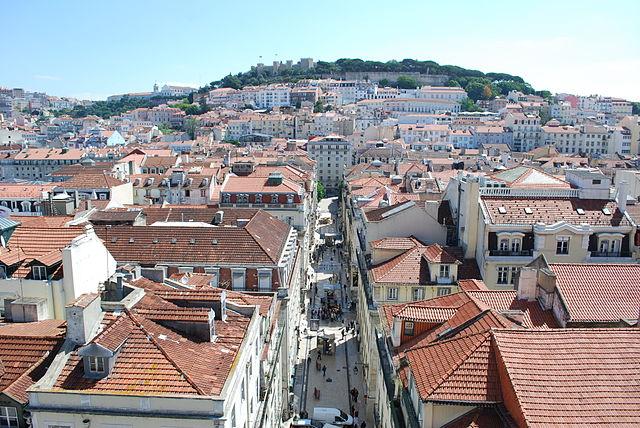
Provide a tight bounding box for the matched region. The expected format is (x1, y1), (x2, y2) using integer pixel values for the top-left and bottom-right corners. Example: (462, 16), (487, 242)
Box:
(0, 320), (65, 404)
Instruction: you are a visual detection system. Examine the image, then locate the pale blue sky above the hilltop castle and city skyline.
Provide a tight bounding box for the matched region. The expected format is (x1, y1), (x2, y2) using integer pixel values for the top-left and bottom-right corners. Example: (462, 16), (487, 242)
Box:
(0, 0), (640, 100)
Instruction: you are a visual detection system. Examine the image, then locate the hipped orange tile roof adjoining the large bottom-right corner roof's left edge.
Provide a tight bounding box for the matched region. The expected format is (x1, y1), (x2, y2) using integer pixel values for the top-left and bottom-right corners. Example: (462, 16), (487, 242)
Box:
(406, 332), (502, 403)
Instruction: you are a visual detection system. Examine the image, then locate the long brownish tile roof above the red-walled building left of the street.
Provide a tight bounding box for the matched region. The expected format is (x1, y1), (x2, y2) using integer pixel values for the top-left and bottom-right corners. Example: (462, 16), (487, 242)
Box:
(96, 211), (290, 265)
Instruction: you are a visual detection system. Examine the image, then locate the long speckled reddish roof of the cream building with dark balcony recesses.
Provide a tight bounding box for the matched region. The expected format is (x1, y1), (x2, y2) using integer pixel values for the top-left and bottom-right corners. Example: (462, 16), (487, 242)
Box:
(481, 196), (631, 226)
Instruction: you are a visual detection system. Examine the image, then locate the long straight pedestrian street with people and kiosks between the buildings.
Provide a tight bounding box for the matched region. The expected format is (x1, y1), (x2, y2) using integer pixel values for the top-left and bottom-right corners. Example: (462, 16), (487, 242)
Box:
(294, 198), (373, 427)
